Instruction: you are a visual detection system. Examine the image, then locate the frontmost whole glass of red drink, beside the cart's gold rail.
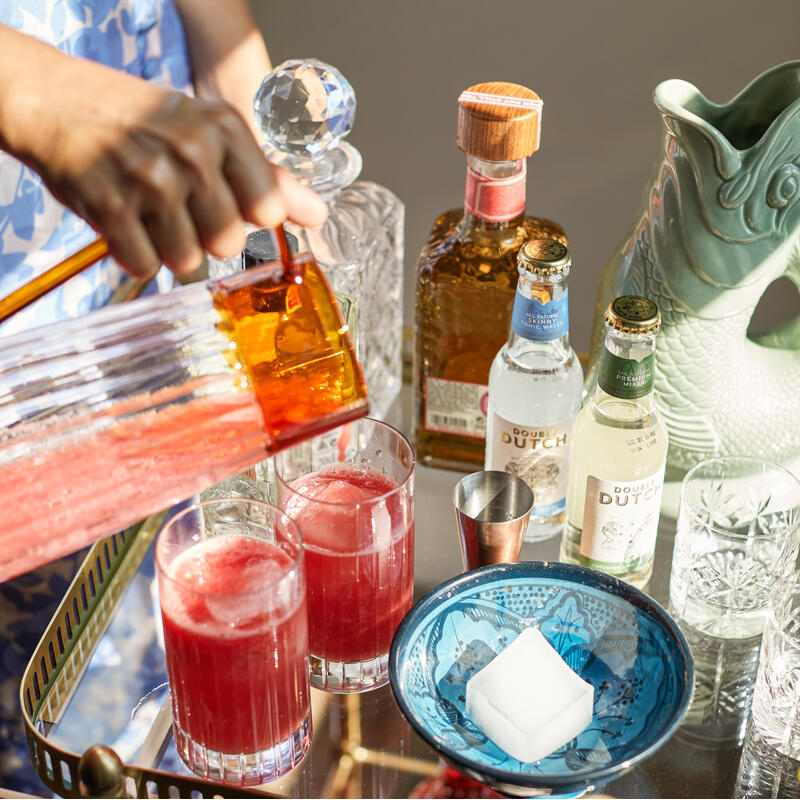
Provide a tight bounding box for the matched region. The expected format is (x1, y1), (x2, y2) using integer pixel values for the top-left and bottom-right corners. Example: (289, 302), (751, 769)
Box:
(156, 498), (311, 786)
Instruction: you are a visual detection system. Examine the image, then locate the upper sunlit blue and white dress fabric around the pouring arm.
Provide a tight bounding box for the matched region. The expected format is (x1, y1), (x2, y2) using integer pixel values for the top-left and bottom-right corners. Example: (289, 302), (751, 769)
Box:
(0, 0), (191, 336)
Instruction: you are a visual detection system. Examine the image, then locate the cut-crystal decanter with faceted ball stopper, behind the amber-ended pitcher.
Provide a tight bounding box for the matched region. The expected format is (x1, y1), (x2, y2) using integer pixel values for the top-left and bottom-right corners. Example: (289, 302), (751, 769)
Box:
(255, 59), (404, 419)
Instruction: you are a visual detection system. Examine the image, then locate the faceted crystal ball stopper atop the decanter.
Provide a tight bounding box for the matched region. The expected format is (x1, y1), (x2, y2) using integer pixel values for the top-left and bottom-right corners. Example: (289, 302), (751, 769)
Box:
(255, 58), (356, 158)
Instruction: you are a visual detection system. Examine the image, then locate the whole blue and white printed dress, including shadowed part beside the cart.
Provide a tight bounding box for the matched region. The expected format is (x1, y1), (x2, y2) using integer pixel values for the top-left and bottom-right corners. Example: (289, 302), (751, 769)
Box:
(0, 0), (191, 795)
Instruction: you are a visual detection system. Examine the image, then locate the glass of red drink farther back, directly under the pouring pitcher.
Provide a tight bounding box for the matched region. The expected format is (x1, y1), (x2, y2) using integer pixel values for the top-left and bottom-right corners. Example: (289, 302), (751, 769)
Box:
(275, 418), (414, 692)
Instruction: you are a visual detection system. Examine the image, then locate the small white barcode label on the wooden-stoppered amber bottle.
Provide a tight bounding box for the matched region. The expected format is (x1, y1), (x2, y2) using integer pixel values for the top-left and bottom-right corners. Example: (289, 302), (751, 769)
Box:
(425, 378), (489, 439)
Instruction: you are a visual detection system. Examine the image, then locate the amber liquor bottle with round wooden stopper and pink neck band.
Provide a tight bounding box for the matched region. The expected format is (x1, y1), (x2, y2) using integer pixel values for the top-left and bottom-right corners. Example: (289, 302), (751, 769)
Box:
(414, 83), (566, 469)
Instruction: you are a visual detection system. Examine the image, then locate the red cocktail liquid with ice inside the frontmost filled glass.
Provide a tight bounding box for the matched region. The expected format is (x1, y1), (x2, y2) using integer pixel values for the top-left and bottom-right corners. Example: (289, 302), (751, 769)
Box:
(160, 535), (310, 754)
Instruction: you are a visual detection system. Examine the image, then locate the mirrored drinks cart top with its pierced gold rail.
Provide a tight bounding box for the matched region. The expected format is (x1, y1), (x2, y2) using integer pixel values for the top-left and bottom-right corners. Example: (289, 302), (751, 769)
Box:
(23, 460), (739, 797)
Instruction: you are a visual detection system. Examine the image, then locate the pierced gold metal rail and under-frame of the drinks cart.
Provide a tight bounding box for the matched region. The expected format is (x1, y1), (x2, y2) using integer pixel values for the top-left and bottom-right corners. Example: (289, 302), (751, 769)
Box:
(20, 511), (440, 798)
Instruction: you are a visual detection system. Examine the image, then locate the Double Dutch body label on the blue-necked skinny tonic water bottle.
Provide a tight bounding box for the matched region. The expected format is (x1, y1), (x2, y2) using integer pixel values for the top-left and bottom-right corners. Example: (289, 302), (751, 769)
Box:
(485, 410), (575, 519)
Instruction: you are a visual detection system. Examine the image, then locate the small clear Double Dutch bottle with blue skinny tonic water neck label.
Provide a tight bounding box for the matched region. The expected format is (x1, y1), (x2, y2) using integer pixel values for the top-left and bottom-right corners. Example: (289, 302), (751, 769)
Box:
(485, 239), (583, 541)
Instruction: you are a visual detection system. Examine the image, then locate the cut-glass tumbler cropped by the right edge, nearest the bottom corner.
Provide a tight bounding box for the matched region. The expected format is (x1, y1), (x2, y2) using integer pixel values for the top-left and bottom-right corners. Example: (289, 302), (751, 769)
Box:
(734, 572), (800, 797)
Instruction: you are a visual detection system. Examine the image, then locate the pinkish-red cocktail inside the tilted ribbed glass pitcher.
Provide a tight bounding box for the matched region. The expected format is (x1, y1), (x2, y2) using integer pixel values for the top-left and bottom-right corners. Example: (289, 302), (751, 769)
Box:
(0, 378), (268, 580)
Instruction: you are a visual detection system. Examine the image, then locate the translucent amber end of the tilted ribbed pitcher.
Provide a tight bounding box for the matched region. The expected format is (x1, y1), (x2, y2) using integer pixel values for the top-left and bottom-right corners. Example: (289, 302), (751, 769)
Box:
(214, 253), (368, 453)
